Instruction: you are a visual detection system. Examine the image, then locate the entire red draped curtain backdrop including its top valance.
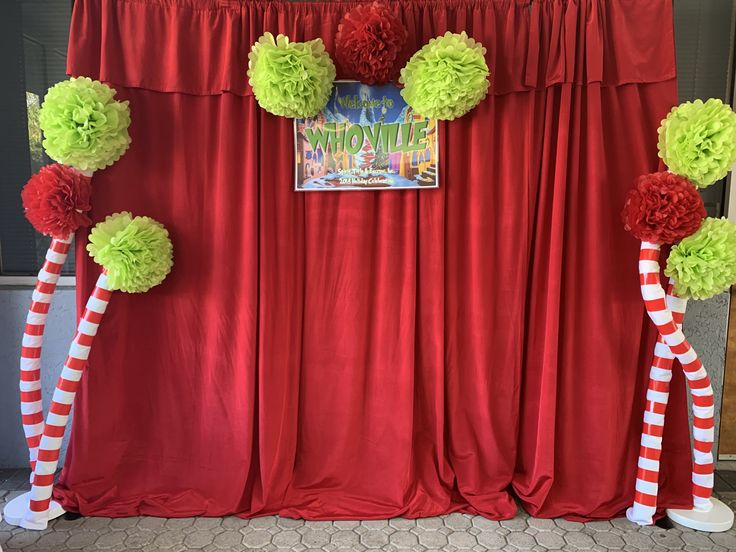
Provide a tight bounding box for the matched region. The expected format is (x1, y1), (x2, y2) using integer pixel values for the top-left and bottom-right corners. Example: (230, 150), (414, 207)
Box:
(56, 0), (691, 519)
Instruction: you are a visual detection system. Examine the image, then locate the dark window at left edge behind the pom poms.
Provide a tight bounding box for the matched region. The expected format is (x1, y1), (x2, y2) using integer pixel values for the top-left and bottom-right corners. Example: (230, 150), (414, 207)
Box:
(0, 0), (74, 275)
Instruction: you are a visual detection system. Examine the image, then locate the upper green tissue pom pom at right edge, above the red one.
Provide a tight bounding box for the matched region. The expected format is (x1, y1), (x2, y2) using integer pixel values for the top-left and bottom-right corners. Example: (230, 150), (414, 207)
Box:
(658, 98), (736, 188)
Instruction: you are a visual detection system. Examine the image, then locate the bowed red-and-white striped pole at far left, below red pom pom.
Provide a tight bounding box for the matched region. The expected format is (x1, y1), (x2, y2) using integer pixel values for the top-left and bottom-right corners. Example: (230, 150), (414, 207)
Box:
(20, 234), (72, 471)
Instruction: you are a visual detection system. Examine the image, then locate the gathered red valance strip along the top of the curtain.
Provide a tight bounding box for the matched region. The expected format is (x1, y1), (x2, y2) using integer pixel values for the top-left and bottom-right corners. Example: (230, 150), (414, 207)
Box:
(68, 0), (675, 95)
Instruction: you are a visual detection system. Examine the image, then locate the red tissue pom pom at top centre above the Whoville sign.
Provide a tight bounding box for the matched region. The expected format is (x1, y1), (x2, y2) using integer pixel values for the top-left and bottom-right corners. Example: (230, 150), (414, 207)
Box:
(335, 2), (409, 84)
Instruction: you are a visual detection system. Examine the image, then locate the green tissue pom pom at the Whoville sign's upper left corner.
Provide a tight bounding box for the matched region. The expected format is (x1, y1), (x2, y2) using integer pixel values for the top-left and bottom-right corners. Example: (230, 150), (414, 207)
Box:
(248, 33), (335, 119)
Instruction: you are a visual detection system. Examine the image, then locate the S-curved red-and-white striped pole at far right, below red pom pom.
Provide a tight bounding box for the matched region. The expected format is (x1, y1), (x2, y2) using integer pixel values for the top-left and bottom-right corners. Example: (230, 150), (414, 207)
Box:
(637, 242), (715, 511)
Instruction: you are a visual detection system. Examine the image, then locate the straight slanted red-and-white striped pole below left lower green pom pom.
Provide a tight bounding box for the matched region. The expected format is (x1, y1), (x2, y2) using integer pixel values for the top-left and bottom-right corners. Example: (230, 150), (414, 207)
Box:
(21, 271), (112, 529)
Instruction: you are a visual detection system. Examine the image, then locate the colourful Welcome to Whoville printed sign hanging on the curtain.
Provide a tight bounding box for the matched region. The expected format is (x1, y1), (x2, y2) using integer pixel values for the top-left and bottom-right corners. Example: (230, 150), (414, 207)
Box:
(294, 81), (438, 191)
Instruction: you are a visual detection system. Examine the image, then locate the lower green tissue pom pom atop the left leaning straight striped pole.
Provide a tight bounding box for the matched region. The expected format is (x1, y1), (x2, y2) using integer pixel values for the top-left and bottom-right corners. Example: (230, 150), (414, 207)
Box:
(87, 211), (174, 293)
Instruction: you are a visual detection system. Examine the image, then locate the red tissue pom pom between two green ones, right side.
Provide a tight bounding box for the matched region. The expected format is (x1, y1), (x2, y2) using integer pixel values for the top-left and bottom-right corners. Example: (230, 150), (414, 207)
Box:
(621, 172), (706, 244)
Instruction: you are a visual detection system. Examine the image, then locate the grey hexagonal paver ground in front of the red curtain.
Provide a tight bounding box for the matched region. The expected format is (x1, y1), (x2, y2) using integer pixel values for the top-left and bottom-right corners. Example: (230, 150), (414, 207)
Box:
(0, 470), (736, 552)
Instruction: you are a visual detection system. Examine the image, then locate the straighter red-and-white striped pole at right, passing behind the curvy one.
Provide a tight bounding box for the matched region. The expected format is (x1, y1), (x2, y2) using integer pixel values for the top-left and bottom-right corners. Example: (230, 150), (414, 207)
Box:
(626, 280), (687, 525)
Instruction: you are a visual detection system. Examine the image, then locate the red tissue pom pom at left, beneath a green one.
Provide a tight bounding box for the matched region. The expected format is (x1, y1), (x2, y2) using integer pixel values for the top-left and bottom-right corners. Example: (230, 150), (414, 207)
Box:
(20, 163), (92, 238)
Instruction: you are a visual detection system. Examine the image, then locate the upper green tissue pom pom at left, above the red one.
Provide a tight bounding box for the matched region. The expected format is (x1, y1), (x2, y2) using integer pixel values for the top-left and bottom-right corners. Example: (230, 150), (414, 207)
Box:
(38, 77), (130, 171)
